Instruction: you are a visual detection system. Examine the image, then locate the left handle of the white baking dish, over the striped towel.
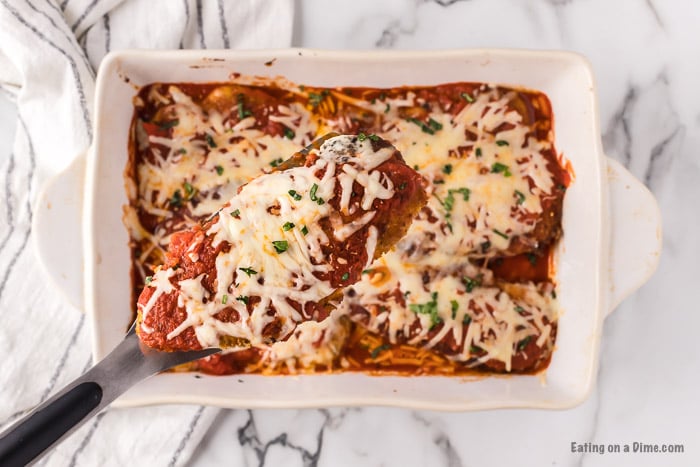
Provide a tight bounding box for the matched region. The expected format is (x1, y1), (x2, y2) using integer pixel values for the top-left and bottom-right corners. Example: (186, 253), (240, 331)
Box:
(32, 154), (85, 310)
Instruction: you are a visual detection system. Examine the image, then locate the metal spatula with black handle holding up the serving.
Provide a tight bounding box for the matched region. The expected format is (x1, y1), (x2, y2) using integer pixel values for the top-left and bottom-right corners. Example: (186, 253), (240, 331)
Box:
(0, 323), (220, 466)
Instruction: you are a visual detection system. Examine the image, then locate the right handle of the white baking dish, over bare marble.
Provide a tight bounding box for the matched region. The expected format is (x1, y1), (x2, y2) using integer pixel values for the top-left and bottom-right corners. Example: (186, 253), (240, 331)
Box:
(607, 158), (662, 314)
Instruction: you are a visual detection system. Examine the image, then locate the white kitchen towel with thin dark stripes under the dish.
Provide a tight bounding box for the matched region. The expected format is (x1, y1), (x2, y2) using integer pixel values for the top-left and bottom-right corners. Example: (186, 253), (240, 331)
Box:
(0, 0), (293, 466)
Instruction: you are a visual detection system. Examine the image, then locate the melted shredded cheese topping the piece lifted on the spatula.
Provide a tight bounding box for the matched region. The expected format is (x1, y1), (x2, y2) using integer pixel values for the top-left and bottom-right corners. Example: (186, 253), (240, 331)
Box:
(141, 136), (394, 348)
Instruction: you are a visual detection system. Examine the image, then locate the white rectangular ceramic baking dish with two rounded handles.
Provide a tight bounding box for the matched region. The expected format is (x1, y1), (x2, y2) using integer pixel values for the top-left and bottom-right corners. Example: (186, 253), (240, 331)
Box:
(30, 49), (661, 410)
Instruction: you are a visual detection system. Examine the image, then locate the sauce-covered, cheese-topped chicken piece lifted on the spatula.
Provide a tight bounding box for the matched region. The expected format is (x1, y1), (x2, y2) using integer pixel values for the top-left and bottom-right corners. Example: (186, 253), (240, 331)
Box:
(137, 134), (427, 351)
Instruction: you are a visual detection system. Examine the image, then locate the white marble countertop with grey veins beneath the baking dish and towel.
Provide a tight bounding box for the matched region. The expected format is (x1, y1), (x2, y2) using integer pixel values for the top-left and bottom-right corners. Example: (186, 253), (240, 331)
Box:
(0, 0), (700, 467)
